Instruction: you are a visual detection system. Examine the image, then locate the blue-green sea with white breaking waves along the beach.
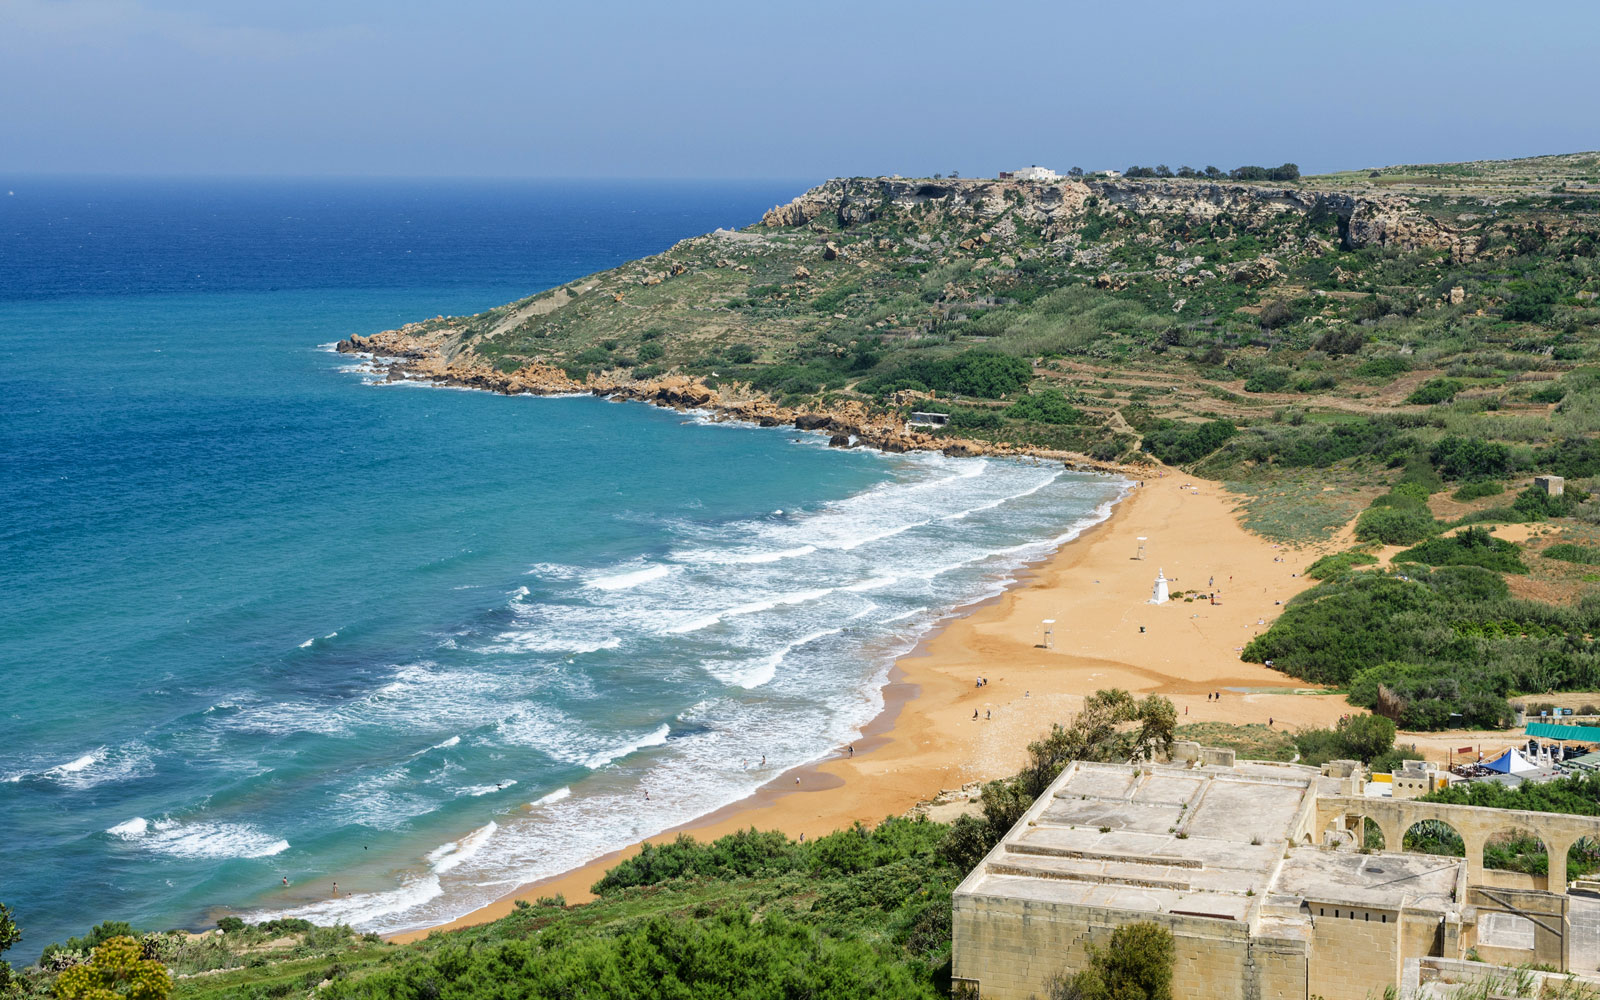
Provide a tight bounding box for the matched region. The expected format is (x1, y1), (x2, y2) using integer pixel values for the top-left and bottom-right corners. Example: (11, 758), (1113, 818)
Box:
(0, 178), (1118, 960)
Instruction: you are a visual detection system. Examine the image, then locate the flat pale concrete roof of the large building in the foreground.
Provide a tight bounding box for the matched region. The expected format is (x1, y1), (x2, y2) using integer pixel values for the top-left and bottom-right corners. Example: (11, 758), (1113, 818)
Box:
(957, 762), (1461, 936)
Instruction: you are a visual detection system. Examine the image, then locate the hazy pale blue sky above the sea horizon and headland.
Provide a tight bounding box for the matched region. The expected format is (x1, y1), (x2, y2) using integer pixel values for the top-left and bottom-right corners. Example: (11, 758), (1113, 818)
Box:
(0, 0), (1600, 178)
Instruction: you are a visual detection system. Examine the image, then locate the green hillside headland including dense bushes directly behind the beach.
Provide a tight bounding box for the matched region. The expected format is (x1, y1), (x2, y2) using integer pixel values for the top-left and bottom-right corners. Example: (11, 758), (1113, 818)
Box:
(341, 154), (1600, 728)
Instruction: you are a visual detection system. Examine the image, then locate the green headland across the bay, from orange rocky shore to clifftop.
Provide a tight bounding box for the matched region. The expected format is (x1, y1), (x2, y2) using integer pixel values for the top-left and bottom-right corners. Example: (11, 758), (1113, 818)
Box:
(344, 154), (1600, 486)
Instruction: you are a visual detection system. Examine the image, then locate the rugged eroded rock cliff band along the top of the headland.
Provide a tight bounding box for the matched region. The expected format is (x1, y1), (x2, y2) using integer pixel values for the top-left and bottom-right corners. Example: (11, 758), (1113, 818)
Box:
(762, 178), (1472, 259)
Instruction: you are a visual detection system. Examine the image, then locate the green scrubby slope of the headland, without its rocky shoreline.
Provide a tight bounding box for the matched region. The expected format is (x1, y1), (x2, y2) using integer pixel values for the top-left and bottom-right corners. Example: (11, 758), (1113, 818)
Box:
(406, 155), (1600, 539)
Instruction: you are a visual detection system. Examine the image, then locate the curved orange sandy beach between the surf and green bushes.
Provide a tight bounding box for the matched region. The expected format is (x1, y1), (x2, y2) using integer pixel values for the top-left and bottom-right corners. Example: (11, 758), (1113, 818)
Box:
(395, 470), (1350, 941)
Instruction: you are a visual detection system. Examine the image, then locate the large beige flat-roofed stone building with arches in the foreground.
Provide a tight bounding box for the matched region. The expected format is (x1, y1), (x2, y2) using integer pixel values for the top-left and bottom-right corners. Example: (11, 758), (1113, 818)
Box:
(954, 744), (1600, 1000)
